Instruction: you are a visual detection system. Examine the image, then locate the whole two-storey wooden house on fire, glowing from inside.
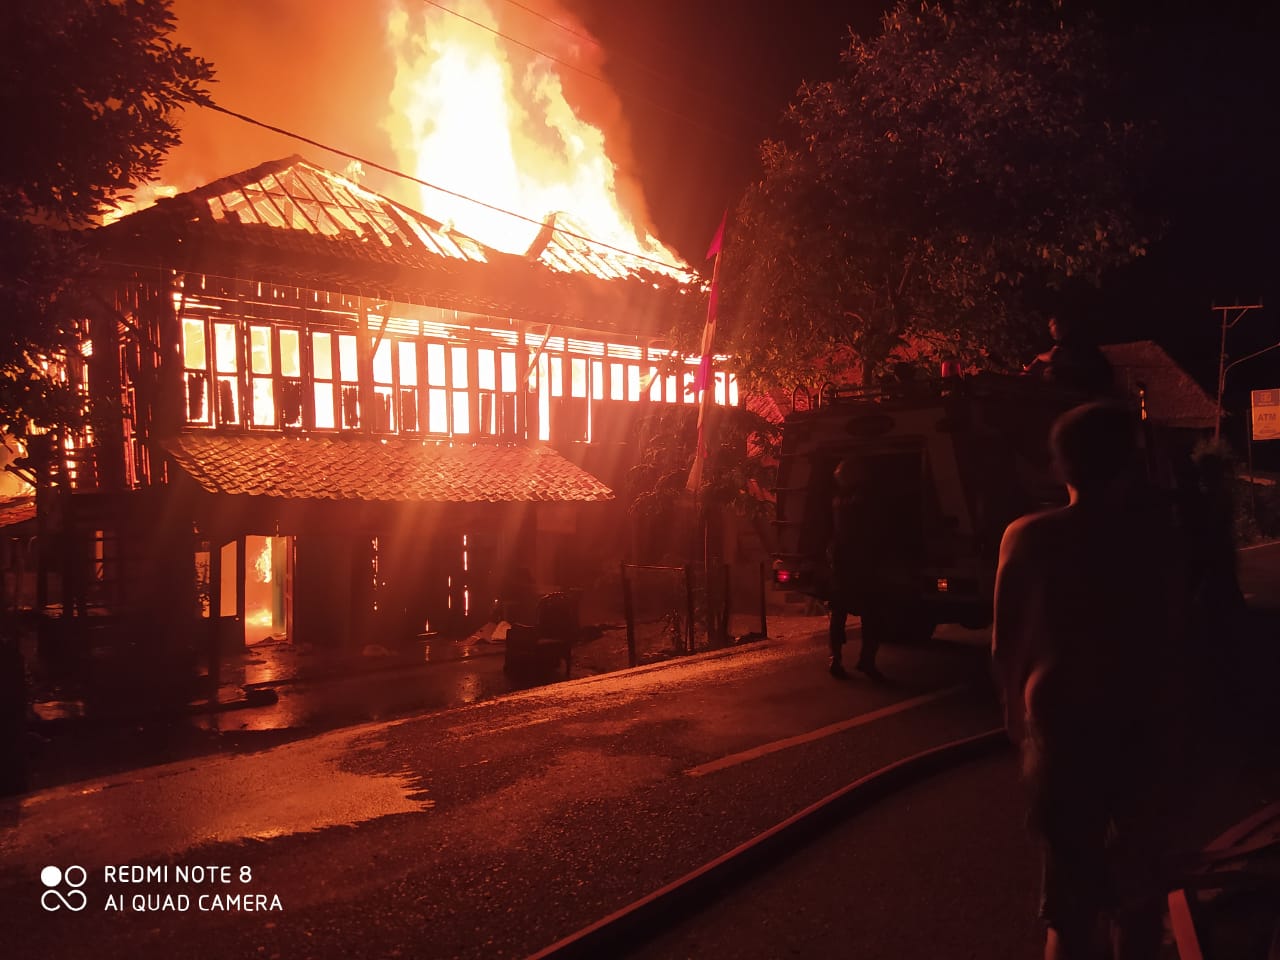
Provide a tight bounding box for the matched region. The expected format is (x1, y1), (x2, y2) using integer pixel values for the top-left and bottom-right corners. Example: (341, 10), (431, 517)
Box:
(32, 156), (737, 648)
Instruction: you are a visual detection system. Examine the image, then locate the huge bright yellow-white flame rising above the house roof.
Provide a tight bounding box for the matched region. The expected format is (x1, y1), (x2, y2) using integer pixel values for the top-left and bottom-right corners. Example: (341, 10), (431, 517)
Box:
(385, 0), (684, 266)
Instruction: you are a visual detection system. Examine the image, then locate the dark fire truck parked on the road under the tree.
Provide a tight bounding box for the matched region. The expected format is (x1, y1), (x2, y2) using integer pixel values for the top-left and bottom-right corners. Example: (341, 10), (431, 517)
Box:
(773, 374), (1082, 641)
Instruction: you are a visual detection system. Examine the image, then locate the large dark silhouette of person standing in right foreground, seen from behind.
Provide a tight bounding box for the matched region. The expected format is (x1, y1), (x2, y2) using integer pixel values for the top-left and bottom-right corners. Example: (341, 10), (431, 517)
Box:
(992, 402), (1185, 960)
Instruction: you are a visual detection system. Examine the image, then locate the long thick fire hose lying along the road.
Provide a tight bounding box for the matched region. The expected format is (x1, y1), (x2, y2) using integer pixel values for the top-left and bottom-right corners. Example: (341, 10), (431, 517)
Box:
(527, 727), (1010, 960)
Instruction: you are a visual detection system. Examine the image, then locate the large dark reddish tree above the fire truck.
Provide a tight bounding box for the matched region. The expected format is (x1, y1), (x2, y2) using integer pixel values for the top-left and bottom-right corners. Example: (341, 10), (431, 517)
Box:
(722, 0), (1146, 387)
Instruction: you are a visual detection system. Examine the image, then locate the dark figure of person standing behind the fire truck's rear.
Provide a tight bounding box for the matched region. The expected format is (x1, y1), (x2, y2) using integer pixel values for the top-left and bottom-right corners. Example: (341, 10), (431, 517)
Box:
(827, 460), (884, 680)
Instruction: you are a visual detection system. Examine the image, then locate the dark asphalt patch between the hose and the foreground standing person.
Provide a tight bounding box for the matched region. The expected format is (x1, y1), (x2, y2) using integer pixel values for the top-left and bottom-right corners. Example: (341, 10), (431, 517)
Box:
(628, 751), (1044, 960)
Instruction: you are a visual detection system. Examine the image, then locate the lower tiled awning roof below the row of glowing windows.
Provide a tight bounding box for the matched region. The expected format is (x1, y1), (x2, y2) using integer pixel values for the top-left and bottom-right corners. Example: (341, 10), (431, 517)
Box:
(164, 433), (613, 503)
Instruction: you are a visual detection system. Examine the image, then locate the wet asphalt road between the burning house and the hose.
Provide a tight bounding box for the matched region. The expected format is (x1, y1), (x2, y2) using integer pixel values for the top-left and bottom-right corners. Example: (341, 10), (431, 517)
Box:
(0, 627), (997, 960)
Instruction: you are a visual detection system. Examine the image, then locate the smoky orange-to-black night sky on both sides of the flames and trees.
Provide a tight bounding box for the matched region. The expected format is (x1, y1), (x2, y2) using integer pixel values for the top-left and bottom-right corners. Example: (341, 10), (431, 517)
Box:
(160, 0), (1280, 435)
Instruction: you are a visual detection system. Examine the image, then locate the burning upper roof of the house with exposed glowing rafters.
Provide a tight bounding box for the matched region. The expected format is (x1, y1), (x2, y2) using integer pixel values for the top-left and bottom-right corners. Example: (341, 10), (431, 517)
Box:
(96, 155), (698, 332)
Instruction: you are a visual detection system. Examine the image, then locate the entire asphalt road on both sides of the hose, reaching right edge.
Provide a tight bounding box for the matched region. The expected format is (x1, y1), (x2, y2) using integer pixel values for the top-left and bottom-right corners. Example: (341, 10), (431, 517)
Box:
(10, 548), (1280, 960)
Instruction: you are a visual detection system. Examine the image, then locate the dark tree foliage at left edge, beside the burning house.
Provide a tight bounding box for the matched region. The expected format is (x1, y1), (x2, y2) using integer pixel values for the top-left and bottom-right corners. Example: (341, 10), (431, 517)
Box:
(0, 0), (212, 435)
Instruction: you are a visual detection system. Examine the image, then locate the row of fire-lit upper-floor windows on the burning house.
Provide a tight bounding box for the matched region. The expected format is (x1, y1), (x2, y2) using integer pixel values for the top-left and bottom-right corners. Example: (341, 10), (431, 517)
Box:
(182, 317), (737, 440)
